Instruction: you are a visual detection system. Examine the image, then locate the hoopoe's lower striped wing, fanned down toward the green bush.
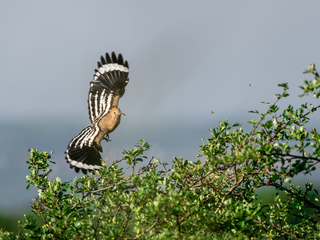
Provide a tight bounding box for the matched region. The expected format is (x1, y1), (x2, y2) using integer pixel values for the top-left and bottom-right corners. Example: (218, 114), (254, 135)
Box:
(65, 126), (102, 174)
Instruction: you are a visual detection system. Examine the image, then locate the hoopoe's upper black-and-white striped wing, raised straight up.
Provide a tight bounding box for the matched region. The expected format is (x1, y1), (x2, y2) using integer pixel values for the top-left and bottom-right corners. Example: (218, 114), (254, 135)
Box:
(88, 52), (129, 124)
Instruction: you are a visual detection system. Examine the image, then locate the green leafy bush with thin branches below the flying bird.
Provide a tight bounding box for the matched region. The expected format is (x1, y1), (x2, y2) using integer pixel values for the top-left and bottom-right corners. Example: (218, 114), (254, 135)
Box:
(0, 64), (320, 239)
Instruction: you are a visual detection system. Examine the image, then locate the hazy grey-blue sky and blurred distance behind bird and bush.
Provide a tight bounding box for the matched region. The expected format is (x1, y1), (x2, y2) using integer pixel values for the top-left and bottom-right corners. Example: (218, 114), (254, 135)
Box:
(0, 0), (320, 212)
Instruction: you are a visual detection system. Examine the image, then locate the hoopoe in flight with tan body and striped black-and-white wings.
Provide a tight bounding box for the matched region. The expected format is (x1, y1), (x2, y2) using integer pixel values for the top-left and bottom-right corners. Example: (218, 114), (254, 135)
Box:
(65, 52), (129, 174)
